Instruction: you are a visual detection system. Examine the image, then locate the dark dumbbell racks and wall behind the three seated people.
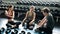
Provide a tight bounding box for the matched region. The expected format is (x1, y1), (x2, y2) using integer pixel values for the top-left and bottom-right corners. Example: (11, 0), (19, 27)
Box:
(0, 0), (60, 27)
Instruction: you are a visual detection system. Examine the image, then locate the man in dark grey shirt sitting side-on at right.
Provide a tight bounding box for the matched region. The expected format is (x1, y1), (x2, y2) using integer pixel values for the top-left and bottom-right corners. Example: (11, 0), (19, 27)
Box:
(38, 7), (55, 34)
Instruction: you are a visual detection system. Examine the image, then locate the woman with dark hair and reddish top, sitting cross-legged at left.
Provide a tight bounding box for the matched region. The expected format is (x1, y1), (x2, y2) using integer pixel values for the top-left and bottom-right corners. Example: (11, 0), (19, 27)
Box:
(5, 5), (16, 28)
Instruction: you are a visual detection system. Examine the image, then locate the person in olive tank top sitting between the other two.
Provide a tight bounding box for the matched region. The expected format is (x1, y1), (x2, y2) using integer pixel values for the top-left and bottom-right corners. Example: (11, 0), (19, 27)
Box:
(22, 6), (36, 29)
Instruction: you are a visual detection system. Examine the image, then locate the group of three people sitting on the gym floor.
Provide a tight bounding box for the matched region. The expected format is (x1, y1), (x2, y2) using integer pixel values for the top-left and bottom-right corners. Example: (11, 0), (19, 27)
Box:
(5, 5), (54, 34)
